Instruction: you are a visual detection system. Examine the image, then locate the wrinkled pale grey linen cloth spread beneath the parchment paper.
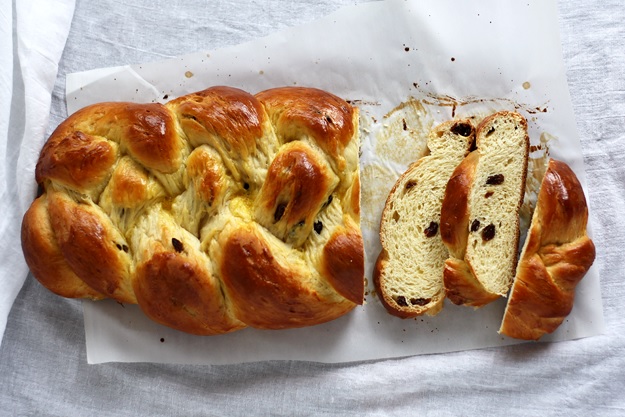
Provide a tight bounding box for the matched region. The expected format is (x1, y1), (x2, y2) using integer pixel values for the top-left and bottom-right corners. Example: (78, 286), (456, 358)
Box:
(0, 0), (625, 416)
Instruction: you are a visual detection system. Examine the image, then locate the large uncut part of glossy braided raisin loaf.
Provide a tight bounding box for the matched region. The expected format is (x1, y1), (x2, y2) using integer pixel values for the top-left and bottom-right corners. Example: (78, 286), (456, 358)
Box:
(22, 87), (364, 335)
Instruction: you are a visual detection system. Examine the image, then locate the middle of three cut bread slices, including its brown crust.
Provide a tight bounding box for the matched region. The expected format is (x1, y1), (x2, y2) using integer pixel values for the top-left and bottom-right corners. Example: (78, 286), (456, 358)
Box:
(441, 111), (529, 307)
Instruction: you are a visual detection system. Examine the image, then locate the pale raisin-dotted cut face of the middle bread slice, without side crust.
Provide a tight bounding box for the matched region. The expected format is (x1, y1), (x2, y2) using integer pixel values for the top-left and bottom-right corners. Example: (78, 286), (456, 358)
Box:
(466, 113), (527, 295)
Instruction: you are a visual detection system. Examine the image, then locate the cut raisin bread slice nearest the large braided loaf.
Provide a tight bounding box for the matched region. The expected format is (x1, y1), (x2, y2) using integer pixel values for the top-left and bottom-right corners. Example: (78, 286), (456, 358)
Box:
(373, 119), (475, 318)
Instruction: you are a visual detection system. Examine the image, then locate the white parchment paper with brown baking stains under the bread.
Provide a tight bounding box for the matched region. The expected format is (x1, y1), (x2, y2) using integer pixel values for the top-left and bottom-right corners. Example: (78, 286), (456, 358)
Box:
(62, 0), (604, 364)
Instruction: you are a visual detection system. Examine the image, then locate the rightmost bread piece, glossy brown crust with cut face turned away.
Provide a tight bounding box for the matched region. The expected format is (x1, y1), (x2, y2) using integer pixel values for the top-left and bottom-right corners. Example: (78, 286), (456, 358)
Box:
(499, 159), (595, 340)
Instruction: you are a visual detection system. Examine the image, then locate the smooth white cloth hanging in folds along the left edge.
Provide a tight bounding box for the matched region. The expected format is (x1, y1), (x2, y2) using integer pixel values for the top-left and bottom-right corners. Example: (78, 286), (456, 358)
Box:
(0, 0), (74, 343)
